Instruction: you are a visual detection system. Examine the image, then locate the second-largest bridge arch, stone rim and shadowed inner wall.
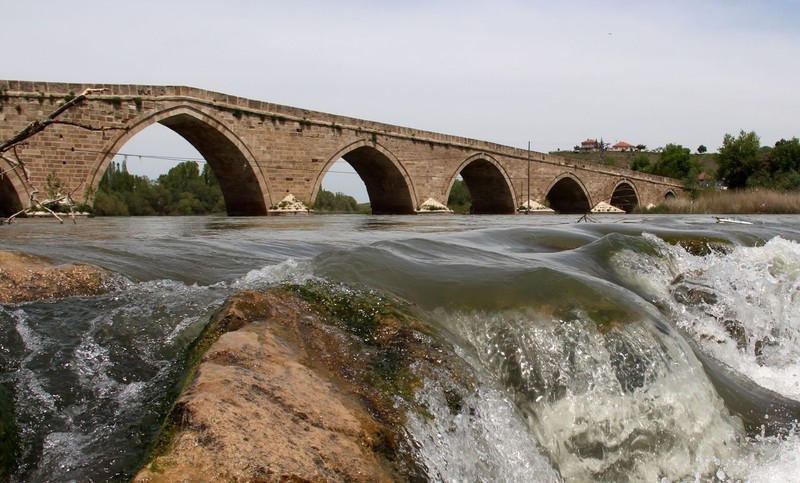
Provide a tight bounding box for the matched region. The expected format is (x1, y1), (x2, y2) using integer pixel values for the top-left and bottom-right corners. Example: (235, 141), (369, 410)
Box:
(311, 139), (417, 215)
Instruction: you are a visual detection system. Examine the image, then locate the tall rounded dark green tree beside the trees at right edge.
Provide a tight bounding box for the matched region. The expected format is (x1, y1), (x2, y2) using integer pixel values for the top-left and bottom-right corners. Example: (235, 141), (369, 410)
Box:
(717, 130), (761, 189)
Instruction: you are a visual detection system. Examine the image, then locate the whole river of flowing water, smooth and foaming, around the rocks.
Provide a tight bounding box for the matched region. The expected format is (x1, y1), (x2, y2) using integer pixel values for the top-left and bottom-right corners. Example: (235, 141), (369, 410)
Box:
(0, 215), (800, 481)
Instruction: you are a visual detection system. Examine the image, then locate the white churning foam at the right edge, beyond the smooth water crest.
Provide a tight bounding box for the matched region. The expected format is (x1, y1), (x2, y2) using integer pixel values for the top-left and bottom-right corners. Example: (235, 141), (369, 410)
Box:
(614, 236), (800, 400)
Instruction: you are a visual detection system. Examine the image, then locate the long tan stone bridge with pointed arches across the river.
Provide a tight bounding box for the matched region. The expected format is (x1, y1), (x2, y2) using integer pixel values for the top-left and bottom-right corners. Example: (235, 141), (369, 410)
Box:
(0, 80), (684, 215)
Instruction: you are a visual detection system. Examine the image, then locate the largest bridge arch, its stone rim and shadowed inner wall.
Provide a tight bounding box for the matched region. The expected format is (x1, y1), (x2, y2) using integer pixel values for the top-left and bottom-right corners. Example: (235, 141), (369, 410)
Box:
(87, 105), (271, 216)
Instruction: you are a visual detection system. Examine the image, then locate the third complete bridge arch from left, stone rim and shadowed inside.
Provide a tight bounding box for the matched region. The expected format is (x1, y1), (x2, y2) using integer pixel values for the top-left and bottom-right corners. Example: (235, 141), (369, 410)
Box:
(444, 153), (516, 215)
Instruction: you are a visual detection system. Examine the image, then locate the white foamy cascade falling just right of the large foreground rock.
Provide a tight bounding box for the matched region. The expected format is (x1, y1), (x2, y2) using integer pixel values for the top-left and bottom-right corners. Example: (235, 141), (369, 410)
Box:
(446, 311), (743, 481)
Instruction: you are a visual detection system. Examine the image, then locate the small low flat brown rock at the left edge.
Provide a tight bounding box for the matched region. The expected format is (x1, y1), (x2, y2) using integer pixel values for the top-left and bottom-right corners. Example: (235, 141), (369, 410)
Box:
(0, 251), (119, 304)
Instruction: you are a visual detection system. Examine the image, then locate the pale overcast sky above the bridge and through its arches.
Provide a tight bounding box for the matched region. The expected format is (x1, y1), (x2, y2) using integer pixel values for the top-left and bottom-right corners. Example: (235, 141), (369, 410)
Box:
(0, 0), (800, 198)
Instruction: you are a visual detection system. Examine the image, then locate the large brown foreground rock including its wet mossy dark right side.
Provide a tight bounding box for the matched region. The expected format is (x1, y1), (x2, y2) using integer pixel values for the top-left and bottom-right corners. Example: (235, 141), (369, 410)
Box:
(135, 284), (472, 481)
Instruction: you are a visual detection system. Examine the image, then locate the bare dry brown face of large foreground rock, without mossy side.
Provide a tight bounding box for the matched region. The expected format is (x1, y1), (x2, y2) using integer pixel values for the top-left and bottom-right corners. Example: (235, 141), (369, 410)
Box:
(135, 290), (412, 482)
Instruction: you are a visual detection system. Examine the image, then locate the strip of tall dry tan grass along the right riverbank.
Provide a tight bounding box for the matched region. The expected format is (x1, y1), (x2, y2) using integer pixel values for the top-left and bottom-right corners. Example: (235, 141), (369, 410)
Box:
(642, 189), (800, 214)
